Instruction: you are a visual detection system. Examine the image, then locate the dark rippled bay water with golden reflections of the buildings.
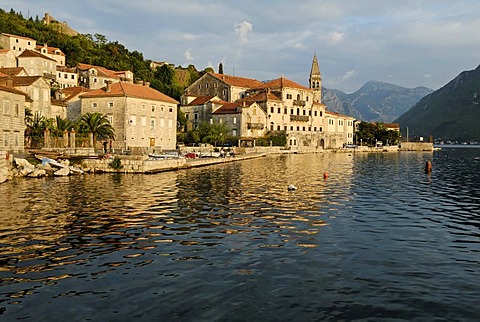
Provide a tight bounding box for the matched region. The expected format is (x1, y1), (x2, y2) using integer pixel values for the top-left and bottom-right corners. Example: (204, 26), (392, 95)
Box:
(0, 148), (480, 321)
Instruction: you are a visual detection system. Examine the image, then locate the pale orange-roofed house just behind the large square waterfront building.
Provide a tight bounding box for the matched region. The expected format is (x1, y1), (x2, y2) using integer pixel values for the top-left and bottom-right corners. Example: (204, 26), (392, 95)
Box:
(77, 63), (133, 89)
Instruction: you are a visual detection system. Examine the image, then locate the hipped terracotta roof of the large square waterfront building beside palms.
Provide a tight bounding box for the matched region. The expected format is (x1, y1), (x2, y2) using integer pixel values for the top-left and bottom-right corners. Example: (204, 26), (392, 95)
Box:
(81, 82), (179, 104)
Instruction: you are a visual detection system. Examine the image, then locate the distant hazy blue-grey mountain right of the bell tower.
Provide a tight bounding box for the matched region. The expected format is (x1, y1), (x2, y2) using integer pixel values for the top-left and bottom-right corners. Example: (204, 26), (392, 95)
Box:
(322, 81), (433, 123)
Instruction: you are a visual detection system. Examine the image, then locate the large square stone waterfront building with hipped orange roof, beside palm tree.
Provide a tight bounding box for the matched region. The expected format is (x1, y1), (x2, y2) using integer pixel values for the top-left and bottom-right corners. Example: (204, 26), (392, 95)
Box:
(80, 82), (178, 152)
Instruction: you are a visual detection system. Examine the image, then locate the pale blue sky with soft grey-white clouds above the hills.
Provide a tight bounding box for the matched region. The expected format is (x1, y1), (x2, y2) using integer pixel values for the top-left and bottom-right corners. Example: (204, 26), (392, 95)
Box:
(0, 0), (480, 93)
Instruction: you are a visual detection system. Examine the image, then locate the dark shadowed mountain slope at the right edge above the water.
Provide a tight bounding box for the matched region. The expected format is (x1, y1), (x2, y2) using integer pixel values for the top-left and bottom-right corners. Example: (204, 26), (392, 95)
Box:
(395, 66), (480, 141)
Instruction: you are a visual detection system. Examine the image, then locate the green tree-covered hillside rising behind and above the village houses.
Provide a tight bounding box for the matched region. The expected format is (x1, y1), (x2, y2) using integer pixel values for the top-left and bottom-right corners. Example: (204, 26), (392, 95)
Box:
(0, 9), (212, 100)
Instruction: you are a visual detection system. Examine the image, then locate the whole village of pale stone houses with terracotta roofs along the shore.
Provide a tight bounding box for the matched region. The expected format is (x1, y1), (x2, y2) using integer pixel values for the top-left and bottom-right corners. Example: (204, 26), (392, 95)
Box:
(0, 33), (364, 153)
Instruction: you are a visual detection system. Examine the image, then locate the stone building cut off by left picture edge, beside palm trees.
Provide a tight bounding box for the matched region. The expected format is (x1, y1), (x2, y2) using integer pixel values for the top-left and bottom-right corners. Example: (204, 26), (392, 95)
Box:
(0, 80), (27, 153)
